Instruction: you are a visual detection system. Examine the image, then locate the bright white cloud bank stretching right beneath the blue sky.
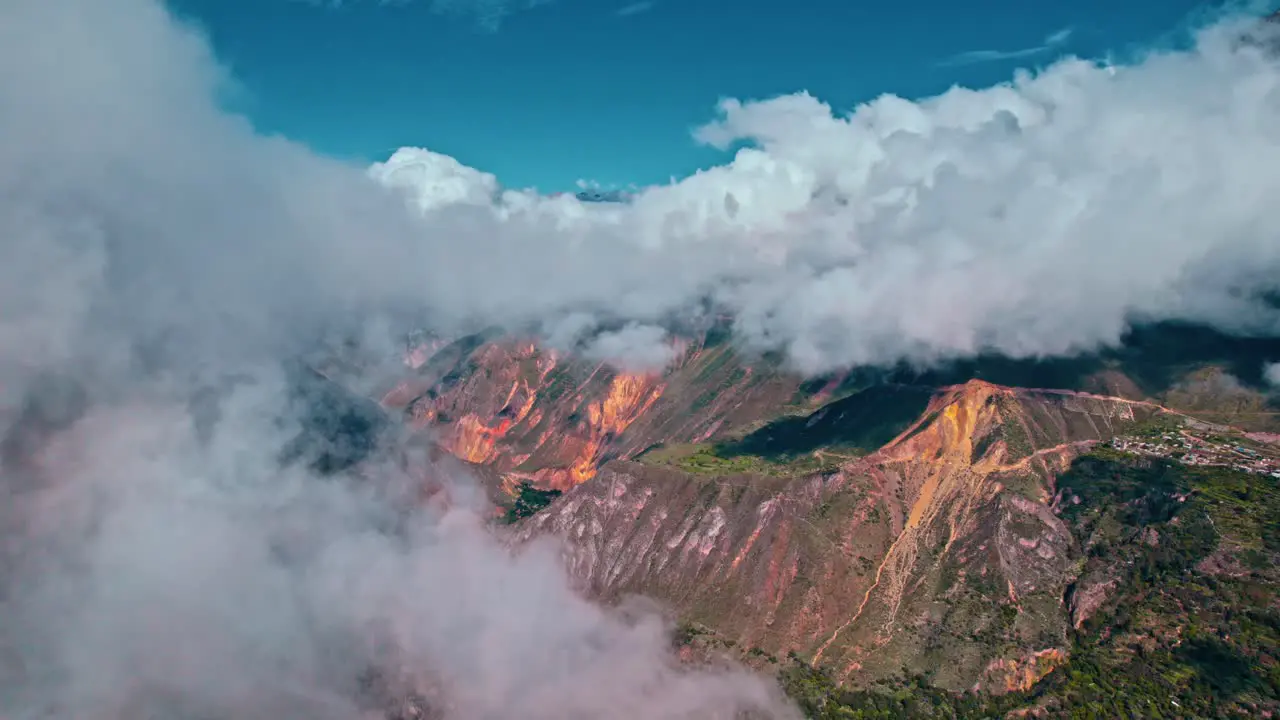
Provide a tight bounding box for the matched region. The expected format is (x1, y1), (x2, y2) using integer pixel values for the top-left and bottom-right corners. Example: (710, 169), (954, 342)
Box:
(372, 20), (1280, 372)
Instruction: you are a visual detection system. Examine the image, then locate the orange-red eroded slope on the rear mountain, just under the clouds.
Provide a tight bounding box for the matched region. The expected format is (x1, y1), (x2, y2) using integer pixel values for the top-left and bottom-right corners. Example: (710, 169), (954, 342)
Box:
(380, 338), (800, 489)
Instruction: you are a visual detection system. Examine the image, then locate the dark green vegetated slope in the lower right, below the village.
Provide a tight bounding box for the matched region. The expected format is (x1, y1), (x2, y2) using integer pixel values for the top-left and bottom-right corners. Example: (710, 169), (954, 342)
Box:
(747, 448), (1280, 720)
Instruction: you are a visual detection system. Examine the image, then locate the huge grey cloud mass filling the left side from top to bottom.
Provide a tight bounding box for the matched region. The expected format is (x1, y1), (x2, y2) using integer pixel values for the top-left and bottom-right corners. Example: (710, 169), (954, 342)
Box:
(0, 0), (788, 720)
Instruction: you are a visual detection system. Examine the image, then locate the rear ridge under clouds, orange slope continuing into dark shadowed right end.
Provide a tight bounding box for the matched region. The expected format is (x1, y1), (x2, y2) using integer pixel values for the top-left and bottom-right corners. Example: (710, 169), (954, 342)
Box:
(376, 320), (1280, 499)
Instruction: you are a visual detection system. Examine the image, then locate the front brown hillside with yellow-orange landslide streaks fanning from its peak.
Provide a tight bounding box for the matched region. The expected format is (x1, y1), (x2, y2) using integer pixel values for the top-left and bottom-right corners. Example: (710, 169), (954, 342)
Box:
(521, 380), (1153, 689)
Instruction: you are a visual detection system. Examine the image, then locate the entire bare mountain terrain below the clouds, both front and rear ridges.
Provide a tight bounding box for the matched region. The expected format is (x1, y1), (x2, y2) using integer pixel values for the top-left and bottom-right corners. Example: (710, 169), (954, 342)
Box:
(309, 322), (1280, 717)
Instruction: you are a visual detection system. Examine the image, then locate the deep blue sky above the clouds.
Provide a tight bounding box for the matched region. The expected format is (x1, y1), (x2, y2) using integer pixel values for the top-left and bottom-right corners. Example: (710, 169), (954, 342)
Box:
(170, 0), (1204, 191)
